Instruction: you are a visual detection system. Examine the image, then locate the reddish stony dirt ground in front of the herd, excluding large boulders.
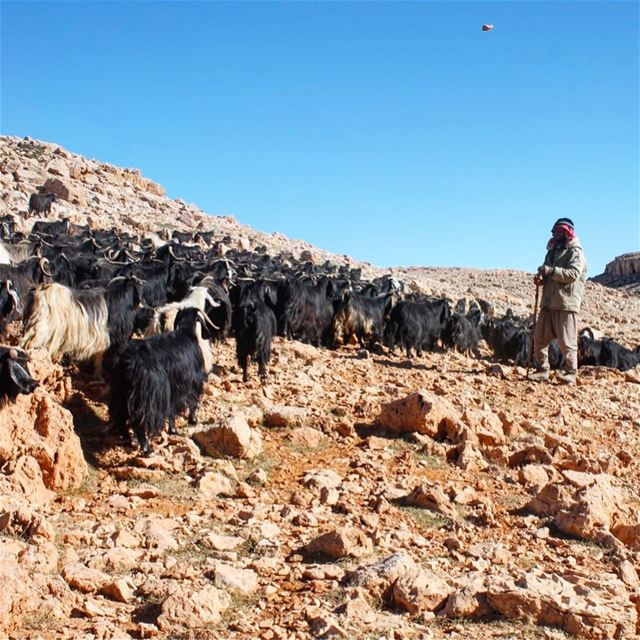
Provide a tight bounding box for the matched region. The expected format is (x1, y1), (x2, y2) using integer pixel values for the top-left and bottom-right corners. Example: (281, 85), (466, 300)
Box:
(9, 330), (640, 639)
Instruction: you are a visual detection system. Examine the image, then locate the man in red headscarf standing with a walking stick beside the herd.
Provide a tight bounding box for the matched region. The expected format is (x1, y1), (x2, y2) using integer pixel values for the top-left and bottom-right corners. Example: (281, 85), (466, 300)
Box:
(529, 218), (587, 384)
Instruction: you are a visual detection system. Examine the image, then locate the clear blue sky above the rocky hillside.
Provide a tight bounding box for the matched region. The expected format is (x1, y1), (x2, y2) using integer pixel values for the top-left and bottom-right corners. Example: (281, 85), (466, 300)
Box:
(0, 0), (640, 275)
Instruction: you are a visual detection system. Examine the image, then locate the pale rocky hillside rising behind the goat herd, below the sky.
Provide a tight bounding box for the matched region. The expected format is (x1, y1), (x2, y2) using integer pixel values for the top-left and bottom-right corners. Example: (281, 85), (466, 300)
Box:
(0, 136), (640, 347)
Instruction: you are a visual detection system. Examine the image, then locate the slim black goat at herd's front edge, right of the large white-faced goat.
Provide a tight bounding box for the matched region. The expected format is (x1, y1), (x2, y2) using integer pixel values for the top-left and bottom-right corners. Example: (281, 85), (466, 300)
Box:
(232, 283), (277, 382)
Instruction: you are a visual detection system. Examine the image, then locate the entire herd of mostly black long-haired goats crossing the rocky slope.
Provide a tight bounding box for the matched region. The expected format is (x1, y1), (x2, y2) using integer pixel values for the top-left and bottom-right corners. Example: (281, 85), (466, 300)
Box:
(0, 203), (640, 455)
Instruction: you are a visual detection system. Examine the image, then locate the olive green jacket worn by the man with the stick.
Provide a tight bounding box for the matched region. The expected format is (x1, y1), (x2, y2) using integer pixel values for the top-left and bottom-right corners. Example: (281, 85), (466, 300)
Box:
(540, 238), (587, 313)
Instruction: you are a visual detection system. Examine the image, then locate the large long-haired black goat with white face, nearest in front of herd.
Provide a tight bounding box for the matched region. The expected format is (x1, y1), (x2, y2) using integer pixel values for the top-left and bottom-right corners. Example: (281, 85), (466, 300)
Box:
(109, 307), (212, 455)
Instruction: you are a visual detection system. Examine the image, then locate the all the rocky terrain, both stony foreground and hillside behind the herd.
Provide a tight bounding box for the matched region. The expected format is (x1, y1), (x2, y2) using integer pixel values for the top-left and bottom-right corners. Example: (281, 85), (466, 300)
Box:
(0, 138), (640, 640)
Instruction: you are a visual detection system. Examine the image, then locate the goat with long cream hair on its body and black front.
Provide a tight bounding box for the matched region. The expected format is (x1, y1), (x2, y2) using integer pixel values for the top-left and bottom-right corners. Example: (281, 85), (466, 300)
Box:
(22, 278), (140, 361)
